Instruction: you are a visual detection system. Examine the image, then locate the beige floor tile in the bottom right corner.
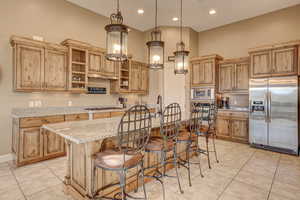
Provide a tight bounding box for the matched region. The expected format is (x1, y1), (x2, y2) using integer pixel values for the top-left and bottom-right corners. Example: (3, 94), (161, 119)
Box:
(271, 179), (300, 200)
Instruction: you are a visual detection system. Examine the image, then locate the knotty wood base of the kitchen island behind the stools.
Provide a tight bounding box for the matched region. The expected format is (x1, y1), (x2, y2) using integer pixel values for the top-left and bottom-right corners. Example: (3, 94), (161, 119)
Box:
(65, 134), (192, 200)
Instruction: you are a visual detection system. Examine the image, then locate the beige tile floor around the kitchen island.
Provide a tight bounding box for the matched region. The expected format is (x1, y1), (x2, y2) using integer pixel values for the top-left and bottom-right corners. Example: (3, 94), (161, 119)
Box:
(0, 140), (300, 200)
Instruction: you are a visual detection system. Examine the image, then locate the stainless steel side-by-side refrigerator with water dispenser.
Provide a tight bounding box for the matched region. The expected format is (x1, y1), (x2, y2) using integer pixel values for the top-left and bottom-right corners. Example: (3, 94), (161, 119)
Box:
(249, 76), (299, 154)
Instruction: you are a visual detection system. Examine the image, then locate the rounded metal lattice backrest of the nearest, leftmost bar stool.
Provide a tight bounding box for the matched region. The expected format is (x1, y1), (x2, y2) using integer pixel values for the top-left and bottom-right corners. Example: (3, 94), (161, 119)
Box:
(118, 105), (152, 154)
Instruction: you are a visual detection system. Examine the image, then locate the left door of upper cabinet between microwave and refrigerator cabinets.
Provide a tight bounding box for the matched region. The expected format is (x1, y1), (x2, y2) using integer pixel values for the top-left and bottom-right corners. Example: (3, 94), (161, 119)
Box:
(219, 64), (234, 92)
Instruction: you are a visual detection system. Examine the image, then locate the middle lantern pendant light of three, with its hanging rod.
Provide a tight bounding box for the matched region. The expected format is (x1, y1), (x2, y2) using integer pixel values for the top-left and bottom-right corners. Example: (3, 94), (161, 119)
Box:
(147, 0), (165, 70)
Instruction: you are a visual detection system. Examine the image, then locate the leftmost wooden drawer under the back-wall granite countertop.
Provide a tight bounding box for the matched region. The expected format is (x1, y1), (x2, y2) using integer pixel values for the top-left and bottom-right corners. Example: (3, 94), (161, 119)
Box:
(20, 115), (64, 128)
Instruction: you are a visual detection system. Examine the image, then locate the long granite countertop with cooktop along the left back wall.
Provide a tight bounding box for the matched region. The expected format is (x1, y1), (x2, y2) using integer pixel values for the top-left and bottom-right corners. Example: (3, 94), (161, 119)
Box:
(11, 105), (156, 118)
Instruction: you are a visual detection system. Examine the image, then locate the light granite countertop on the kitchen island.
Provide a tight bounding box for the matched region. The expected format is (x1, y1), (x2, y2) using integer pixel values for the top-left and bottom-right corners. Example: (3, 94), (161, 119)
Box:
(42, 117), (160, 144)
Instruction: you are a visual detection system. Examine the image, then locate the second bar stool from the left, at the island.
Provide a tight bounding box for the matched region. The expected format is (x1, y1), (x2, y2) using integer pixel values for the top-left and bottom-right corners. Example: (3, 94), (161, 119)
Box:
(145, 103), (183, 199)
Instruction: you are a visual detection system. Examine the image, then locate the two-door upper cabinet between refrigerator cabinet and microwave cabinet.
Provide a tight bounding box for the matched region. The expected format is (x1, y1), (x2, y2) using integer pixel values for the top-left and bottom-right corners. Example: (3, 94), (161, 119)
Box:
(219, 57), (249, 93)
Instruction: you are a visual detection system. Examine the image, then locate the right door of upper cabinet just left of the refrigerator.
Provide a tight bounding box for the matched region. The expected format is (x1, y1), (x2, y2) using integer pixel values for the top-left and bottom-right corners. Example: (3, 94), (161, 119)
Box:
(234, 63), (249, 92)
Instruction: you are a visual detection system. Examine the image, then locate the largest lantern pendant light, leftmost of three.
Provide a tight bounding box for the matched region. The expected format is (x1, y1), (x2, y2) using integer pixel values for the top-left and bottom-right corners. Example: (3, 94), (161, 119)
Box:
(105, 0), (128, 62)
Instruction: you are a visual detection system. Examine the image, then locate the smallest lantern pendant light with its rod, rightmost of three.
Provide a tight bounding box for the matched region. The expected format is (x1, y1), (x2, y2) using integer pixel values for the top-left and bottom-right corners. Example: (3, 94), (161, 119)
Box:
(174, 0), (190, 74)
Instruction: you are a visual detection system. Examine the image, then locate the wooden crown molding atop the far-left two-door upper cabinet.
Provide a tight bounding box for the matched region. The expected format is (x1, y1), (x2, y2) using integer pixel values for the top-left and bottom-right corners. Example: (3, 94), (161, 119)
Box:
(10, 35), (68, 52)
